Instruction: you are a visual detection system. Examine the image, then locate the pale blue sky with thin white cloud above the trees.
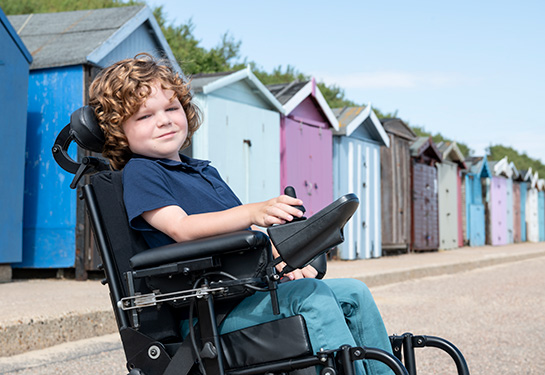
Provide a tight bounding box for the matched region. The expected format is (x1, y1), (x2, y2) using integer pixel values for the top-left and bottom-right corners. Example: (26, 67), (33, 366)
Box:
(143, 0), (545, 163)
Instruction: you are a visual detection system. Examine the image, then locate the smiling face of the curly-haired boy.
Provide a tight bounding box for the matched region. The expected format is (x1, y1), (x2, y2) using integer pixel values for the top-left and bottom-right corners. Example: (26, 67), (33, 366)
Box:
(123, 84), (187, 161)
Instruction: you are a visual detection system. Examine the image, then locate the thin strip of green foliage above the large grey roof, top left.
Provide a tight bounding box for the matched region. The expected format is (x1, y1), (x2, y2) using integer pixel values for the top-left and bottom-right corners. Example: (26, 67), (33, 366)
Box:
(0, 0), (140, 15)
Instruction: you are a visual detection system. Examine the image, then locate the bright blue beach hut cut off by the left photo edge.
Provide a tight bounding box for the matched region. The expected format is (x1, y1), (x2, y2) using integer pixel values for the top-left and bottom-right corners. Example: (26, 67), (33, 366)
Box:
(0, 8), (32, 280)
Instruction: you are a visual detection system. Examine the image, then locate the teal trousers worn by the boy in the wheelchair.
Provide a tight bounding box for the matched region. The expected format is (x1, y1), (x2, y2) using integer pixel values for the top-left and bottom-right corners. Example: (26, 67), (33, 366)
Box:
(220, 279), (392, 375)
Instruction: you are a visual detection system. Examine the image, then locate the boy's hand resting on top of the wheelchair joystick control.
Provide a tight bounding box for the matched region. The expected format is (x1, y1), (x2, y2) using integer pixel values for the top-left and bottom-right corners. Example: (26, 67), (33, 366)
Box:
(251, 195), (303, 227)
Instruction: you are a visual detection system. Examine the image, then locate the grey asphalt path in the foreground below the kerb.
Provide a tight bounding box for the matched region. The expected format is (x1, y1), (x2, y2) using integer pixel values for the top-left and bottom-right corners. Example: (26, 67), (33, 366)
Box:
(0, 257), (545, 375)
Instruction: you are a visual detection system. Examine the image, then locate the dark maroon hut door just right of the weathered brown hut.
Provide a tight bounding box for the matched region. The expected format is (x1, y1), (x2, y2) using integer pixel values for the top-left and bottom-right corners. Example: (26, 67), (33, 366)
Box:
(411, 162), (439, 250)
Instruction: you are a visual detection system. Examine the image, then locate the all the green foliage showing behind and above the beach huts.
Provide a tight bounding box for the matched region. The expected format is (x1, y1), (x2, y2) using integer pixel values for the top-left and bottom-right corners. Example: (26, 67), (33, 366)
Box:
(6, 0), (545, 176)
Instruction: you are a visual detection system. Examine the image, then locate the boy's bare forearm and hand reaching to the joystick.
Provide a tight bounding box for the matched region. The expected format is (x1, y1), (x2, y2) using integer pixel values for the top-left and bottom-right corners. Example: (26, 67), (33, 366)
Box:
(142, 195), (303, 242)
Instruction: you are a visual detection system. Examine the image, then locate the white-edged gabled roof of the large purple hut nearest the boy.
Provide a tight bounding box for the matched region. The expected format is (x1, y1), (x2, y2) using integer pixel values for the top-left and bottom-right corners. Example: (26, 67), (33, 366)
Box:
(267, 78), (339, 130)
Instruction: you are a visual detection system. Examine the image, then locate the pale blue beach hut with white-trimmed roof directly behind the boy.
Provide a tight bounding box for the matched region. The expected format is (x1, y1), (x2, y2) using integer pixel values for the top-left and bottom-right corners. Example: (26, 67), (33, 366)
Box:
(191, 67), (283, 207)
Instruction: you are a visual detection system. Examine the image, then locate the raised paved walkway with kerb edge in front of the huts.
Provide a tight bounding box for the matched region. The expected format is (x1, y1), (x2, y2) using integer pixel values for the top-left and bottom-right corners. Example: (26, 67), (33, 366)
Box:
(0, 243), (545, 357)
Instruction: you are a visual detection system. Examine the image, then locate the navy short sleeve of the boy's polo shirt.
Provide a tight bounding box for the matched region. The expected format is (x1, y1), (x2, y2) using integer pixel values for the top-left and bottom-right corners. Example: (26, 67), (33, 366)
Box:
(123, 159), (177, 231)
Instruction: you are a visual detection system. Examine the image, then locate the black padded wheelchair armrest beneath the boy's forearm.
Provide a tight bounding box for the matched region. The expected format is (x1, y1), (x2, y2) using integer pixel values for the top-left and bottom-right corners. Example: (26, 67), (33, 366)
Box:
(129, 230), (269, 269)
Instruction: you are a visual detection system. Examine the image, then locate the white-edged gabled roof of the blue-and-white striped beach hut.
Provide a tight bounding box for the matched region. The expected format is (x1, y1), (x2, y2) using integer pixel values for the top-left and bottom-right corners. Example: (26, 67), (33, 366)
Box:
(332, 104), (390, 147)
